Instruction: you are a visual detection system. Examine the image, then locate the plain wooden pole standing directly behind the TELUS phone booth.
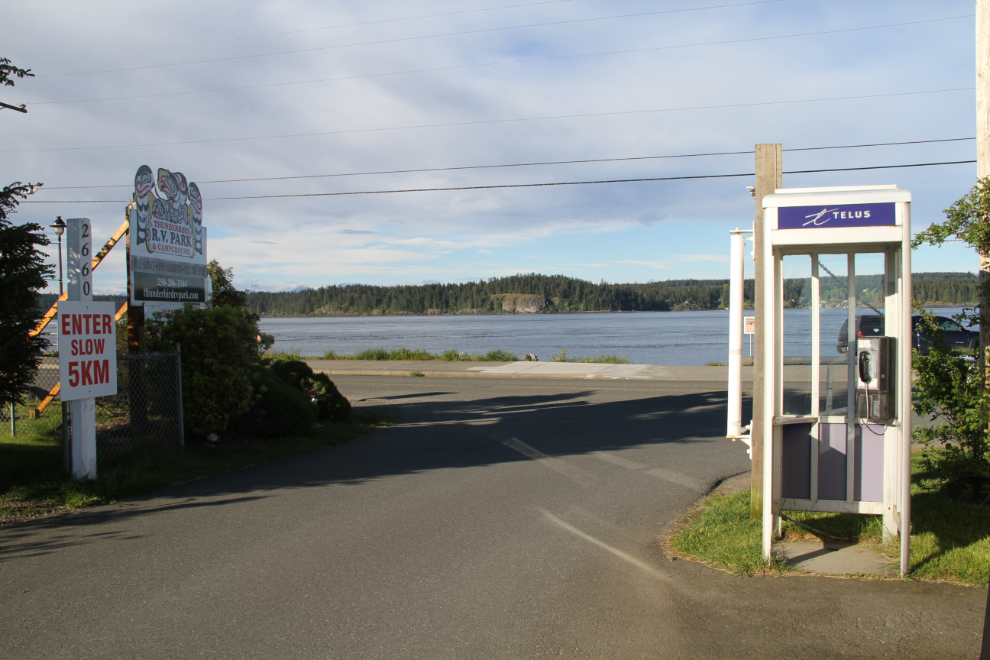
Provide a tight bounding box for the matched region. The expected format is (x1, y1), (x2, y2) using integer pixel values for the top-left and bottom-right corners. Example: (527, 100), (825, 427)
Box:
(749, 144), (784, 520)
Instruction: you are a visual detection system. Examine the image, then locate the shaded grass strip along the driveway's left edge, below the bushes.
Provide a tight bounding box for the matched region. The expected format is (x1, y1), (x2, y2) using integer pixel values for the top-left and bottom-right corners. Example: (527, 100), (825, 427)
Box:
(0, 409), (395, 523)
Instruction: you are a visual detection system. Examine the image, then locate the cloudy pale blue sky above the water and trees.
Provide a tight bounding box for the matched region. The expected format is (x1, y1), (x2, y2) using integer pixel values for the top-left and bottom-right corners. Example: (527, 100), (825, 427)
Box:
(0, 0), (977, 293)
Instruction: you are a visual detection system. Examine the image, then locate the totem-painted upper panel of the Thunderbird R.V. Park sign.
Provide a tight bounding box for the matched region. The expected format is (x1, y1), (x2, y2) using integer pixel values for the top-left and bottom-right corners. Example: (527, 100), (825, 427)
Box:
(132, 165), (204, 258)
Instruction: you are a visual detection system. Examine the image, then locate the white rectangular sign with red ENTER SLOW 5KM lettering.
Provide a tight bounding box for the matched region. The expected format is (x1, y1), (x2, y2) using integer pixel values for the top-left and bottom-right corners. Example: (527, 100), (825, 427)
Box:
(58, 301), (117, 401)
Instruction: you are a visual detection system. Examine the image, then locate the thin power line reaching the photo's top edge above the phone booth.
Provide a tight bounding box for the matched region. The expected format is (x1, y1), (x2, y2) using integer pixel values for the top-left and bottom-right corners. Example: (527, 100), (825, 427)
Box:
(38, 0), (787, 78)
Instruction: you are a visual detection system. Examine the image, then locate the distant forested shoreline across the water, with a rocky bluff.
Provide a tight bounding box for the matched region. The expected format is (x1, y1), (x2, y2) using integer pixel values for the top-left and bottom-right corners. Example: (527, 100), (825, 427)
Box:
(240, 273), (977, 316)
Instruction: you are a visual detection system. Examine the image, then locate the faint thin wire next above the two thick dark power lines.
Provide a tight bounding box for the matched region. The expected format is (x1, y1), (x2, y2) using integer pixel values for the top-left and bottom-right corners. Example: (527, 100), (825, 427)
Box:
(0, 87), (974, 153)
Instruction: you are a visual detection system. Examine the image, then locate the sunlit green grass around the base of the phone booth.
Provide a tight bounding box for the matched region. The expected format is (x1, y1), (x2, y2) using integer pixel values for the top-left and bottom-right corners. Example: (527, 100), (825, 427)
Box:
(666, 452), (990, 586)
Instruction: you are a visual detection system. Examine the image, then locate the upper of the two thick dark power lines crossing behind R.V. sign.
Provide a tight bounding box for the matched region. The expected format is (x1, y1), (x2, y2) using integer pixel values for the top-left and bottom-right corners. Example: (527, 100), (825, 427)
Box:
(39, 137), (976, 192)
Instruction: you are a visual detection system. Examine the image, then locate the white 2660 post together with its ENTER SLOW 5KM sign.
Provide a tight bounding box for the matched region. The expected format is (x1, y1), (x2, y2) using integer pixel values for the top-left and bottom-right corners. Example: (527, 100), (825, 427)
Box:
(58, 218), (117, 479)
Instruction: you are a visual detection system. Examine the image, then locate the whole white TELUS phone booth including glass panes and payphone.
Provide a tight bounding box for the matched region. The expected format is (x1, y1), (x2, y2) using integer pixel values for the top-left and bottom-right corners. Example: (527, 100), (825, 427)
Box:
(762, 185), (912, 575)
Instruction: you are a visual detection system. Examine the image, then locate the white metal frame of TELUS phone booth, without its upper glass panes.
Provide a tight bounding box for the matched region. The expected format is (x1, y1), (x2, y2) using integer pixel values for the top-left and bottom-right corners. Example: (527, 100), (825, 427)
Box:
(762, 185), (912, 575)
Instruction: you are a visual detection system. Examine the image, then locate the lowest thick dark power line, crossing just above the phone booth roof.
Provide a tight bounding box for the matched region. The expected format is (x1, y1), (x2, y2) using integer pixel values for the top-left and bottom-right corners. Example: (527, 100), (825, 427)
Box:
(21, 160), (976, 204)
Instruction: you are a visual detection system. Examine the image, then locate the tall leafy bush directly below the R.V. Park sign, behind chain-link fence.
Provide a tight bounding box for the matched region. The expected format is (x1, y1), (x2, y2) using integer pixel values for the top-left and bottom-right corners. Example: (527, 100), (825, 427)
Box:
(145, 305), (268, 435)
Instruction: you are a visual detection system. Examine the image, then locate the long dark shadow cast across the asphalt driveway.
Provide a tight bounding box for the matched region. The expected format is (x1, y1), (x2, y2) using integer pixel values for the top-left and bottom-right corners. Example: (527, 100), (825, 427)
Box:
(0, 382), (749, 562)
